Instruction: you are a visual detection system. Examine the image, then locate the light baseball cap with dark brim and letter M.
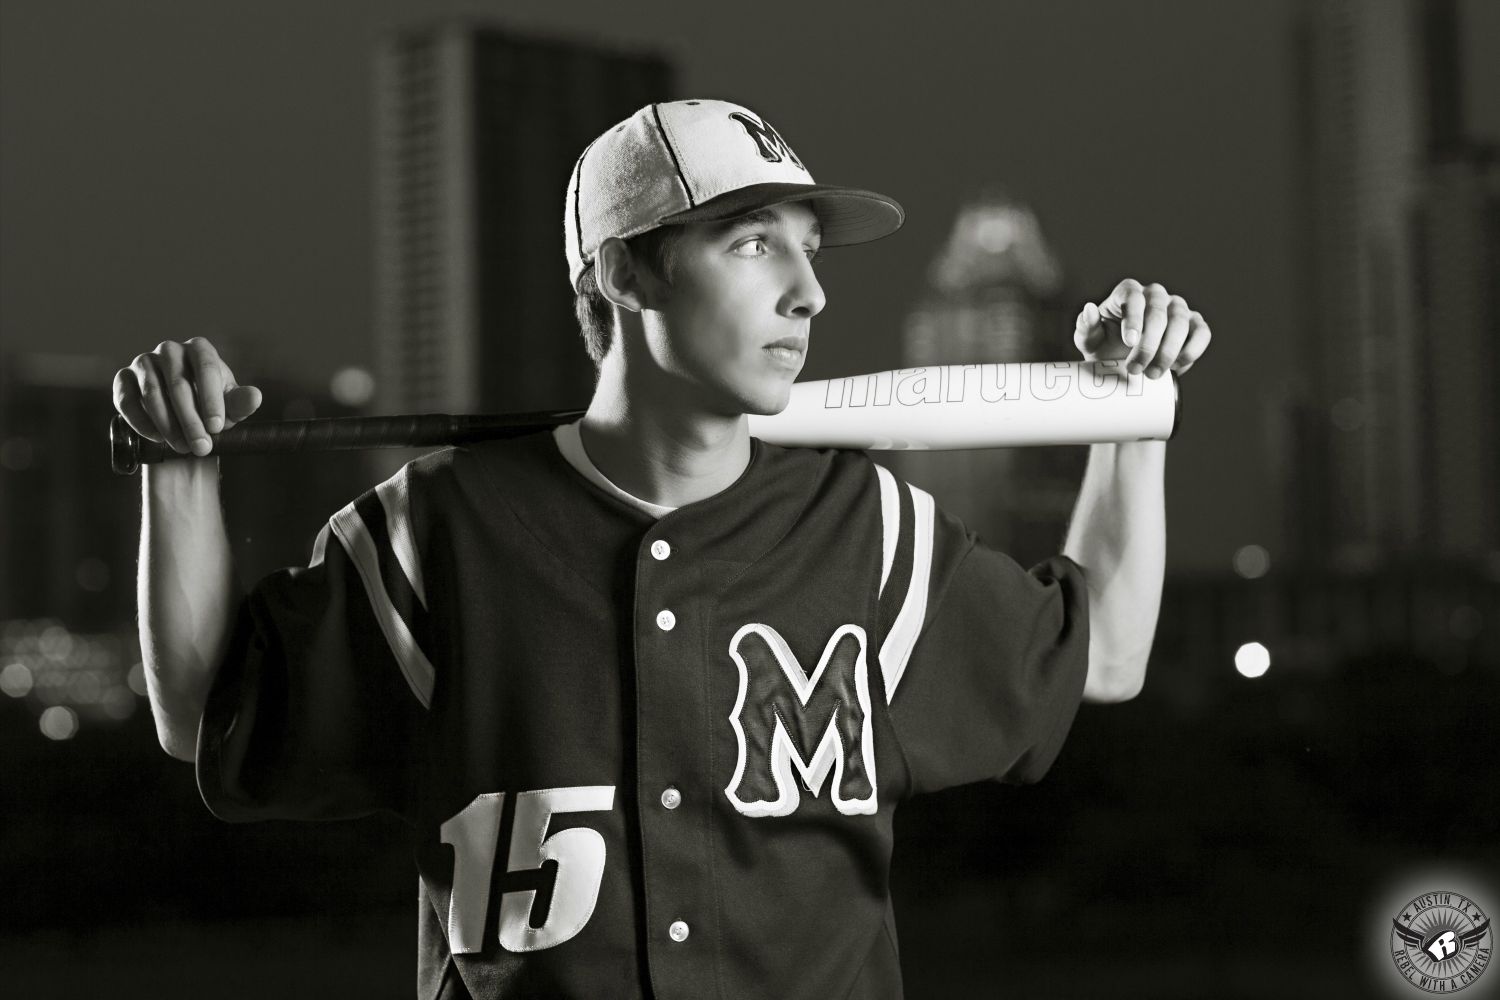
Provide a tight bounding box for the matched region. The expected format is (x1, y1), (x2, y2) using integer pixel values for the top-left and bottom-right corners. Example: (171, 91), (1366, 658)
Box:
(563, 100), (906, 289)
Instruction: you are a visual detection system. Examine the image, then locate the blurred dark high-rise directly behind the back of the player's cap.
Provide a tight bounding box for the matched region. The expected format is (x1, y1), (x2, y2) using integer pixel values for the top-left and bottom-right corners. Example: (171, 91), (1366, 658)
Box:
(375, 21), (674, 412)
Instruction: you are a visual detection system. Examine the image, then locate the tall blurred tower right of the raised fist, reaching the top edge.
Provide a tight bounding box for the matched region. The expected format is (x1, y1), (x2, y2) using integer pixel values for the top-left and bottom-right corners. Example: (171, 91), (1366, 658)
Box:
(1275, 0), (1424, 567)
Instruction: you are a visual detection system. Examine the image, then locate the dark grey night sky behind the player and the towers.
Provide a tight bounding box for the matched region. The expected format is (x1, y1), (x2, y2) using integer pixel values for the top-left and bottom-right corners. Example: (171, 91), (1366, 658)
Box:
(0, 0), (1500, 570)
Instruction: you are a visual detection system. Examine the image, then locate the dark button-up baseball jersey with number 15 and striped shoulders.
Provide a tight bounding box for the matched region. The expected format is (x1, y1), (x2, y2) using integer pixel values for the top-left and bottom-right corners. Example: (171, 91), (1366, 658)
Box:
(198, 433), (1088, 1000)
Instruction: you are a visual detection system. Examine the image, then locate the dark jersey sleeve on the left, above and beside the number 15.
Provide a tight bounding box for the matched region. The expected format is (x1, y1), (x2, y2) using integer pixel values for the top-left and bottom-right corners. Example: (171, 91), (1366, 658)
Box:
(197, 491), (431, 820)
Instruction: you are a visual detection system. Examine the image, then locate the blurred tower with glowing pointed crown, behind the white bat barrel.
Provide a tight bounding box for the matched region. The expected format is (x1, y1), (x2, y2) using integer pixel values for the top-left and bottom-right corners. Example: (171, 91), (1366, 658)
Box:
(891, 192), (1085, 562)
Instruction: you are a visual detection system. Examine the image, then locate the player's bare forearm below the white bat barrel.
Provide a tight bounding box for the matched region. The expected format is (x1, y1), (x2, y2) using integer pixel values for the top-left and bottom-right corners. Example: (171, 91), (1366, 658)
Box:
(1064, 441), (1167, 702)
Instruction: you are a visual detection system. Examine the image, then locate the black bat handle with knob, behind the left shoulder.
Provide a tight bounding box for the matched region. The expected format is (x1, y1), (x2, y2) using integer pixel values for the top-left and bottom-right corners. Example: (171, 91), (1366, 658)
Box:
(110, 409), (584, 475)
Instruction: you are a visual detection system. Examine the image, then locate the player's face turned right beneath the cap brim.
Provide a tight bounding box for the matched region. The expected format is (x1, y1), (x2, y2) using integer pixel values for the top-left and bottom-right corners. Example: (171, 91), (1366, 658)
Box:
(642, 204), (824, 415)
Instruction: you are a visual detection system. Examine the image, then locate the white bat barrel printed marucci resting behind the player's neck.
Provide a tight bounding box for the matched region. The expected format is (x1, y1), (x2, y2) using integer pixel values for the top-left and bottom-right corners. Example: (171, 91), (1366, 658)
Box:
(750, 361), (1181, 451)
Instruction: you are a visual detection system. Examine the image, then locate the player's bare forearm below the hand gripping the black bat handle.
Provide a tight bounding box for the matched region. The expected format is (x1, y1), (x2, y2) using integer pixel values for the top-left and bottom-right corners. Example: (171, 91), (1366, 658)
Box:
(137, 459), (239, 760)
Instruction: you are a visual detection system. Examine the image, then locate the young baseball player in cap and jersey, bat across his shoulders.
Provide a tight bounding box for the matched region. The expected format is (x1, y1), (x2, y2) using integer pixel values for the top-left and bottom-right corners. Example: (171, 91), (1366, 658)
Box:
(116, 100), (1209, 999)
